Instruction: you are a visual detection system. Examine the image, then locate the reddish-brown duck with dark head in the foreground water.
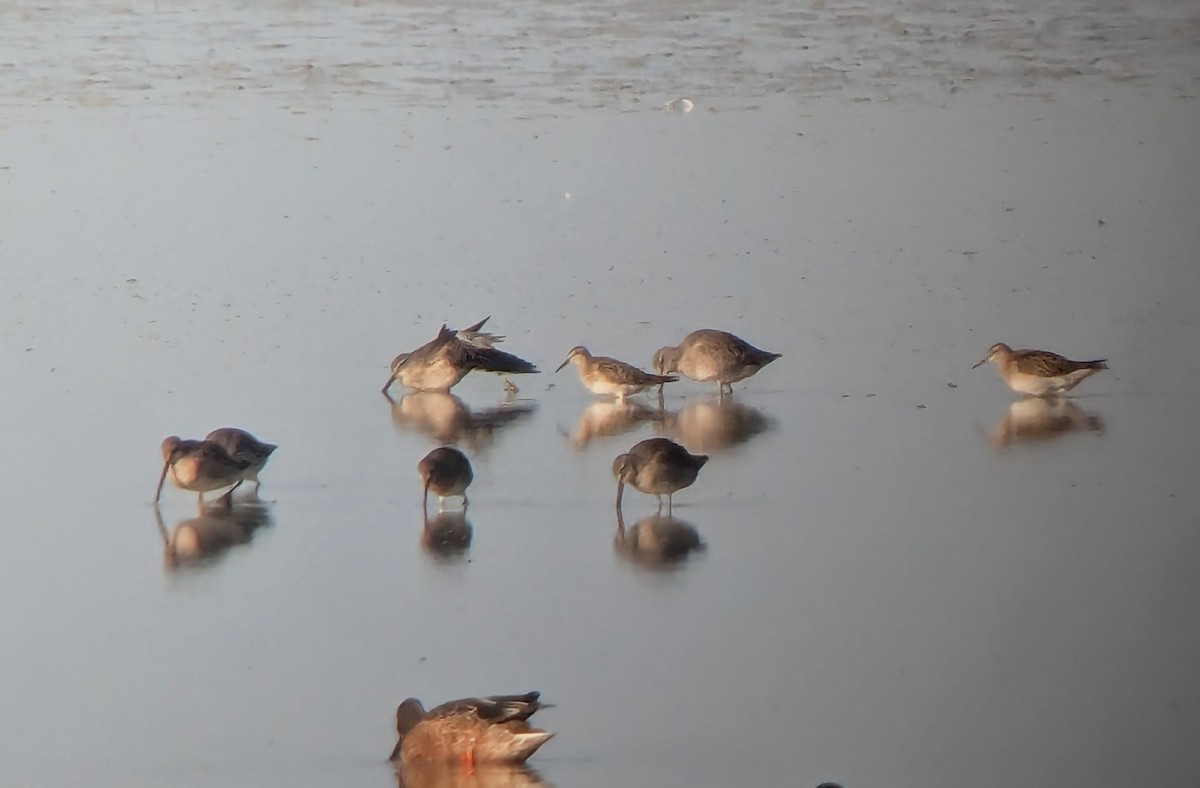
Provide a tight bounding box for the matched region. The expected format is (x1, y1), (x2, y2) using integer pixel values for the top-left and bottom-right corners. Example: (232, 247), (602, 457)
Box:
(391, 692), (554, 768)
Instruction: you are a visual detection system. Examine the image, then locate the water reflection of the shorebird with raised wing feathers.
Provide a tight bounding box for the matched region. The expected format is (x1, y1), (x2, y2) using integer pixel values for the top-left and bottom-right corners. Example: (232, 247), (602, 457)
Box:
(384, 391), (538, 446)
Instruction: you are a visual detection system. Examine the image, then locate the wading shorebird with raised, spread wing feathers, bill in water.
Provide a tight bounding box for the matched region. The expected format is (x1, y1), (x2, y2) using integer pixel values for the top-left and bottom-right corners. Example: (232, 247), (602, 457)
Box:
(383, 318), (538, 395)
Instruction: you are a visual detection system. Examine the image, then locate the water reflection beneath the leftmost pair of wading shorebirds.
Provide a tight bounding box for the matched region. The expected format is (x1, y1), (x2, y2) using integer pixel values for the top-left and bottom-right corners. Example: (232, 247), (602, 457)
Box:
(154, 503), (271, 569)
